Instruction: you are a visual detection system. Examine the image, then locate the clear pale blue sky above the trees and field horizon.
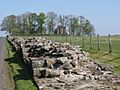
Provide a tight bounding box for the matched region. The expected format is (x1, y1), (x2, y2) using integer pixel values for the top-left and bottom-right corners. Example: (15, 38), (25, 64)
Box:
(0, 0), (120, 35)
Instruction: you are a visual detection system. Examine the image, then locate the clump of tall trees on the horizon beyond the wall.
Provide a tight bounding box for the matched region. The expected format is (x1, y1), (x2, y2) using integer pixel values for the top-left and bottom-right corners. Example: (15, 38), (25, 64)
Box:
(1, 12), (95, 35)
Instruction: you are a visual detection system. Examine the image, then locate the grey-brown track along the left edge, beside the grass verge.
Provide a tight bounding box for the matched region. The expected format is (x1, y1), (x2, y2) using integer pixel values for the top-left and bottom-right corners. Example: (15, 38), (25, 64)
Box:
(0, 37), (14, 90)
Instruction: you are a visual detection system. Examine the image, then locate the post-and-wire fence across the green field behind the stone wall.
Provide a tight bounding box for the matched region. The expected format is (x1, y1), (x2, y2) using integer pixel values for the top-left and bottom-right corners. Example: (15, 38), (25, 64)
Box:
(43, 34), (120, 53)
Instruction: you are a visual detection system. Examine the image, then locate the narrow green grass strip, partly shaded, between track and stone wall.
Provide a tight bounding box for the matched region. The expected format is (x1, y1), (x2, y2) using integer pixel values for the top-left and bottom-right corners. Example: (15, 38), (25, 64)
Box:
(6, 41), (37, 90)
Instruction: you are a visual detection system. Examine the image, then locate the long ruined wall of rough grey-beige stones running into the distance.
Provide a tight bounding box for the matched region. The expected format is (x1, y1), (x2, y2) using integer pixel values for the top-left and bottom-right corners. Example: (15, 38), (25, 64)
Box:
(8, 37), (120, 90)
